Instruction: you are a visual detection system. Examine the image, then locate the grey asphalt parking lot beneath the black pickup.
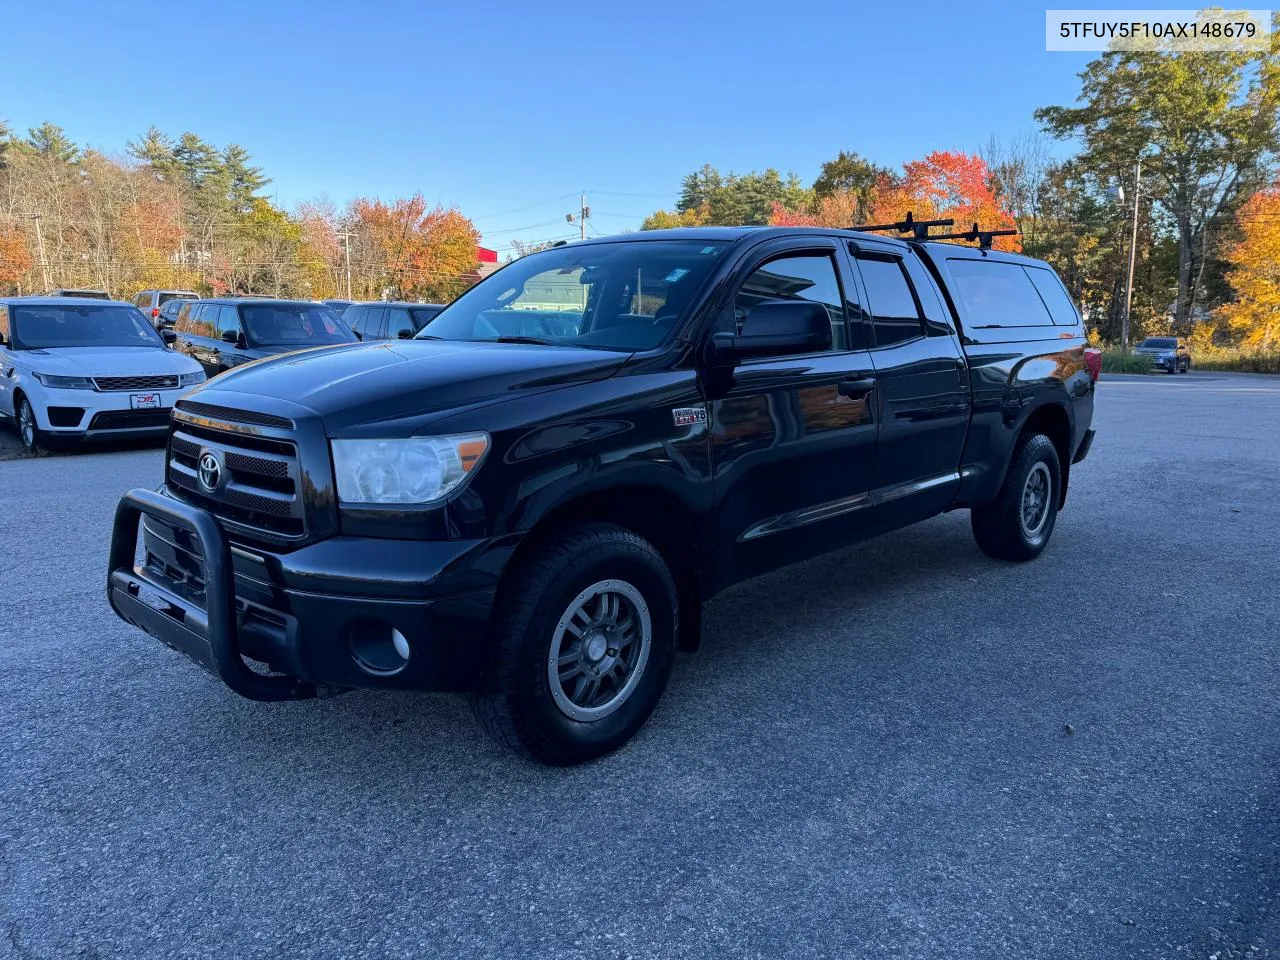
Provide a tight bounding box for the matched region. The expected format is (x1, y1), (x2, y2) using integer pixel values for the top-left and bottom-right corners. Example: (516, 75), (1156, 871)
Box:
(0, 374), (1280, 960)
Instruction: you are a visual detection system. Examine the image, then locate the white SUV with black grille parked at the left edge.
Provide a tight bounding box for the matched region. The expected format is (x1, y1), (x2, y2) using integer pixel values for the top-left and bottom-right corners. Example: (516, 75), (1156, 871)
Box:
(0, 297), (205, 452)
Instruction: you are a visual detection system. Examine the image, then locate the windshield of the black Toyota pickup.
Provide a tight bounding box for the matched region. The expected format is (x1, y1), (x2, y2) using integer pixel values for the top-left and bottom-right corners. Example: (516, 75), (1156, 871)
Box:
(419, 239), (727, 351)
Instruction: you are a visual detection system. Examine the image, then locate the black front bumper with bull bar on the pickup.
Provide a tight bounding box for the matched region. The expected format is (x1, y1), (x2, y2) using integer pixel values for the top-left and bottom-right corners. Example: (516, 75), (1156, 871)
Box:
(108, 490), (516, 700)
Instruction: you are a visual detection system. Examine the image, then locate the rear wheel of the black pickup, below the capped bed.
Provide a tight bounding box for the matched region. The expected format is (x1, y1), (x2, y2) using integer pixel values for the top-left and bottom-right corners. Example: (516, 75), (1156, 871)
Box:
(969, 434), (1062, 561)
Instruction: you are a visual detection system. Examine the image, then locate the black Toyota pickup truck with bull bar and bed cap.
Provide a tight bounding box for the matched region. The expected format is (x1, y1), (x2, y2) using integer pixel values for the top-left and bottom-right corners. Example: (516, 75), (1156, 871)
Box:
(108, 228), (1100, 764)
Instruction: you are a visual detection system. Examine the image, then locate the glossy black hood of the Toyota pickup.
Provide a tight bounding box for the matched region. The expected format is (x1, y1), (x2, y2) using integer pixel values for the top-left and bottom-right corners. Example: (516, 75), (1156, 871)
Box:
(188, 340), (630, 433)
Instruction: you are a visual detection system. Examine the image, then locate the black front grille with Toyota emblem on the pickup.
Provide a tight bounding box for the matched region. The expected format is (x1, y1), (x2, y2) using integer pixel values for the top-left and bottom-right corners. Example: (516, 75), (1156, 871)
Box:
(165, 419), (306, 538)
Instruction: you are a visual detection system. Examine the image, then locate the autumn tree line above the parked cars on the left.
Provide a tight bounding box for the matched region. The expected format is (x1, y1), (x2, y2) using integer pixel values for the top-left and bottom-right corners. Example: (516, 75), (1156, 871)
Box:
(0, 123), (480, 301)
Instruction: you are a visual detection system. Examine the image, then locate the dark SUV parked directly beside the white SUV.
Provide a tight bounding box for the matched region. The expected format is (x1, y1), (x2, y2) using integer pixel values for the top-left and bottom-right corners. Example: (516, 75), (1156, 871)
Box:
(174, 297), (356, 376)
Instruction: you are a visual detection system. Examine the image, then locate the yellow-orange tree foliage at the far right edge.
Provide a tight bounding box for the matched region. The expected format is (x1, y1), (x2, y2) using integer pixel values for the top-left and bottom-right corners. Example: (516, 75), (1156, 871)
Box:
(1220, 184), (1280, 351)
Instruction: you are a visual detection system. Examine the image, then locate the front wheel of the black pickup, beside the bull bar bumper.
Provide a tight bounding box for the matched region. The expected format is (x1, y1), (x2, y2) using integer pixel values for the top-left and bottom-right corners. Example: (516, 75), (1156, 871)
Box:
(472, 524), (677, 765)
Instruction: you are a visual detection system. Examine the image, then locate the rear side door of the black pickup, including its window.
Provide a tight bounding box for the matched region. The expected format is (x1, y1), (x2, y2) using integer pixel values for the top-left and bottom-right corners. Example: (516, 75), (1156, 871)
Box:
(849, 241), (970, 526)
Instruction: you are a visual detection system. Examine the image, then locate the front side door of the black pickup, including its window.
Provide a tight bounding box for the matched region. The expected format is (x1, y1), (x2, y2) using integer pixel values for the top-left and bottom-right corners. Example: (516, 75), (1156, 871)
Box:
(705, 237), (877, 588)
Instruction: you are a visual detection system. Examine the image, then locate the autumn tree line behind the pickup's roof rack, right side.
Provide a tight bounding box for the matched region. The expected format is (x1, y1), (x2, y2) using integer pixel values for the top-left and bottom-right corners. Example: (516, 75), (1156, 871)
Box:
(644, 44), (1280, 351)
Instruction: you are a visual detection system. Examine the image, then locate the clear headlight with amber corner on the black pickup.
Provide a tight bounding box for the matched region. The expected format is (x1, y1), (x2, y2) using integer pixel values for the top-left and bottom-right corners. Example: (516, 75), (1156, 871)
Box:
(329, 434), (489, 504)
